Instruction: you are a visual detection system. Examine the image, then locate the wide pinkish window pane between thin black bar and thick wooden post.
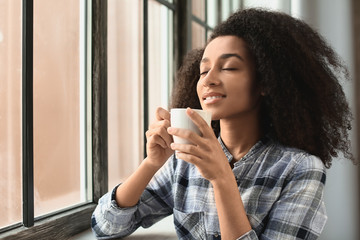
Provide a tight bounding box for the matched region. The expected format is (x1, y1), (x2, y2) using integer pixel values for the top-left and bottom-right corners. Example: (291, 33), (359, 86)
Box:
(34, 0), (87, 216)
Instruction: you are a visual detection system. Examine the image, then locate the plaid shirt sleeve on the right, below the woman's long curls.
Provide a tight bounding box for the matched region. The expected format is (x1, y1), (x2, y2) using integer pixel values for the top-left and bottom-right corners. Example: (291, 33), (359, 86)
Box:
(238, 156), (327, 240)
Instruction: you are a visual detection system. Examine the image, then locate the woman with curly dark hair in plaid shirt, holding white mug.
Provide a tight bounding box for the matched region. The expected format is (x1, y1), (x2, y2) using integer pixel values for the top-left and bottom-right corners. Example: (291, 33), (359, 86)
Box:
(92, 9), (352, 239)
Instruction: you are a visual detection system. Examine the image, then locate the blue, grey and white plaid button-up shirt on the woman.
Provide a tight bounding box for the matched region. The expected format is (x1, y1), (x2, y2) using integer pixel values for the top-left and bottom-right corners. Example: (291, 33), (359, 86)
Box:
(92, 137), (327, 240)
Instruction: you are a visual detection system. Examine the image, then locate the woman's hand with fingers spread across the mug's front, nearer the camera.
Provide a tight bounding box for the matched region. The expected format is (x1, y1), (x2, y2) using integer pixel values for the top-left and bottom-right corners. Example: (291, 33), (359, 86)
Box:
(168, 108), (231, 181)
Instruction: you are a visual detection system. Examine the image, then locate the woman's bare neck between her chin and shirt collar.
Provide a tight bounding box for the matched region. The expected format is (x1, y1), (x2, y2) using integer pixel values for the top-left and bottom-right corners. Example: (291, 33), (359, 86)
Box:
(220, 113), (262, 160)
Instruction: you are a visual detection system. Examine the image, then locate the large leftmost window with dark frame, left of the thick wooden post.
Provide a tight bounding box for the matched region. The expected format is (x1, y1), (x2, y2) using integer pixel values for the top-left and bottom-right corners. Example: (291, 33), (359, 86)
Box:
(0, 0), (98, 238)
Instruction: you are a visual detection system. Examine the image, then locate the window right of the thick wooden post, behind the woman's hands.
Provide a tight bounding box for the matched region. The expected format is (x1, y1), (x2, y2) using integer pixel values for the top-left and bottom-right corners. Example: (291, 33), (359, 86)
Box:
(108, 0), (175, 190)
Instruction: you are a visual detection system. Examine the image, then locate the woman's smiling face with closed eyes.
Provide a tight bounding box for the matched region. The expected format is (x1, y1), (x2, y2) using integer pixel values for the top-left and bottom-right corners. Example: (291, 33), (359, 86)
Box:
(197, 36), (260, 120)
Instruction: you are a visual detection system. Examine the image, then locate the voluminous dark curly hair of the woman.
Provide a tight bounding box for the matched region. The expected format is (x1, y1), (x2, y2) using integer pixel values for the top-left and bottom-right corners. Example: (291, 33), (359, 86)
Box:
(172, 9), (354, 168)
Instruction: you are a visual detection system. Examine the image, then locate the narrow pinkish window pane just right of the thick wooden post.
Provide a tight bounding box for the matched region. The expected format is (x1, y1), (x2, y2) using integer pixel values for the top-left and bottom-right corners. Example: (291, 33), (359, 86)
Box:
(108, 0), (143, 189)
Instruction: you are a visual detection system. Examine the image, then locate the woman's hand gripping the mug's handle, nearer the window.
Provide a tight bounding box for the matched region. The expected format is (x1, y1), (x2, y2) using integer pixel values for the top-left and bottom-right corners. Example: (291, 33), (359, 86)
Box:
(146, 107), (174, 168)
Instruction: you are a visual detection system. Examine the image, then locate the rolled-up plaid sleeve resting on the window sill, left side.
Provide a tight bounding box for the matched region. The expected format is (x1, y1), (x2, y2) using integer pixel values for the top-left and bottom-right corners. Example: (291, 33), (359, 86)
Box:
(91, 156), (173, 239)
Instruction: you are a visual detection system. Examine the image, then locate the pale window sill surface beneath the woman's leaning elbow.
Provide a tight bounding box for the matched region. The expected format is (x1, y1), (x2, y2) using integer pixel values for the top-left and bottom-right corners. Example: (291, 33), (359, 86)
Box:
(70, 216), (178, 240)
